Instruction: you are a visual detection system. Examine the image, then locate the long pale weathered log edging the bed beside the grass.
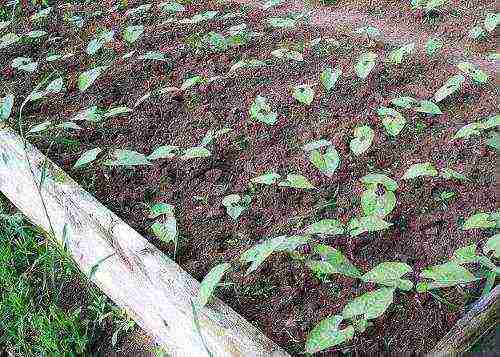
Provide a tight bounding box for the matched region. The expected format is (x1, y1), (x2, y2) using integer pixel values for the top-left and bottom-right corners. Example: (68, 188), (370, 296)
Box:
(0, 123), (288, 357)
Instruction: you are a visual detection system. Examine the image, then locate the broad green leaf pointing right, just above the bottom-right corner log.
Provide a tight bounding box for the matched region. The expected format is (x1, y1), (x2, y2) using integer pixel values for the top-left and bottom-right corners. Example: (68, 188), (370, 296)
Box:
(420, 262), (477, 291)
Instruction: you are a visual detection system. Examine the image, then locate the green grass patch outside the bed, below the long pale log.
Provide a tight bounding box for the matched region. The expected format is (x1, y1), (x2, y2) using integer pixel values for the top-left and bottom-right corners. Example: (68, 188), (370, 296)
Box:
(0, 193), (139, 356)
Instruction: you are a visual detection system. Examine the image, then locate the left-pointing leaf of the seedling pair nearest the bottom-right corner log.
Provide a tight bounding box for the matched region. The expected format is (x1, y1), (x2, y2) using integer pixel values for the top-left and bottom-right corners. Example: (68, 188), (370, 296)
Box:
(361, 262), (413, 291)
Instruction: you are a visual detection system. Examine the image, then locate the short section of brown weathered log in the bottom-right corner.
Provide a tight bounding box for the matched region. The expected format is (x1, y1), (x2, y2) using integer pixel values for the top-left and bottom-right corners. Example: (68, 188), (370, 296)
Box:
(428, 285), (500, 357)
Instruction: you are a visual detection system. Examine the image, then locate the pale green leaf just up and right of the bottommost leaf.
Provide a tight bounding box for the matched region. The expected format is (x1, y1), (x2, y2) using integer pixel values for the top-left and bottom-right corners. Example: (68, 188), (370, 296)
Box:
(342, 288), (396, 320)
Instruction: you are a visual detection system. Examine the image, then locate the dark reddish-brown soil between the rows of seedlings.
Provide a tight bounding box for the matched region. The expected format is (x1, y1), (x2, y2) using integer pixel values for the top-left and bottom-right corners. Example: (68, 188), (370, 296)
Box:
(0, 1), (498, 356)
